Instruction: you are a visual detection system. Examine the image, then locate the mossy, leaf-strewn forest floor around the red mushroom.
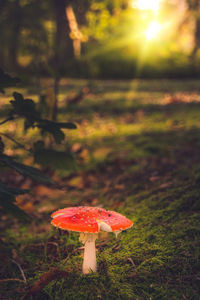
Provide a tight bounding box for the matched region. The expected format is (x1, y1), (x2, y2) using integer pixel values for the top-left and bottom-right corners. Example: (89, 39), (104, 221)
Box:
(0, 80), (200, 300)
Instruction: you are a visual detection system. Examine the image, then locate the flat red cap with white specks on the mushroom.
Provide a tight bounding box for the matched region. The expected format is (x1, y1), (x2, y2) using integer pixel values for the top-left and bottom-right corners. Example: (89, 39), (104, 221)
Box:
(51, 206), (133, 233)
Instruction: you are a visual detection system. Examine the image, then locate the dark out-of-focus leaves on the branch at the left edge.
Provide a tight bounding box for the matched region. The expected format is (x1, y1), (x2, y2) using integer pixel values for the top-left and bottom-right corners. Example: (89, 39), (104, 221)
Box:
(0, 70), (76, 220)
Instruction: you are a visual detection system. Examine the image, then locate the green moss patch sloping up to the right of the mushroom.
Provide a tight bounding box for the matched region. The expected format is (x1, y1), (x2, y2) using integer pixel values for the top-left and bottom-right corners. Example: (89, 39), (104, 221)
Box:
(38, 178), (200, 299)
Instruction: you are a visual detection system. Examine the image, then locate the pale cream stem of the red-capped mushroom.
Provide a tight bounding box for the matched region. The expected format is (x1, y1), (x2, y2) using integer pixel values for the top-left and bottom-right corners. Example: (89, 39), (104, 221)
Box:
(80, 233), (97, 274)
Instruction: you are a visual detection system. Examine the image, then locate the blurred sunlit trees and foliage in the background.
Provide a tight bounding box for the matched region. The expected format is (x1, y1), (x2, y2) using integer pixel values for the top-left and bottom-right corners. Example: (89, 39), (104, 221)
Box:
(0, 0), (200, 78)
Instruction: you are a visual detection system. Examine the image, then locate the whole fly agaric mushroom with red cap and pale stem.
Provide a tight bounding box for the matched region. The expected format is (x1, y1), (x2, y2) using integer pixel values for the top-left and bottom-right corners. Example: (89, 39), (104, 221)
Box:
(51, 206), (133, 274)
